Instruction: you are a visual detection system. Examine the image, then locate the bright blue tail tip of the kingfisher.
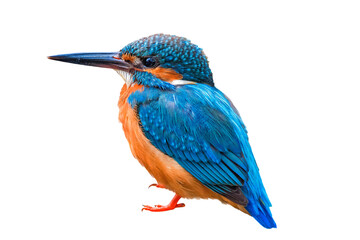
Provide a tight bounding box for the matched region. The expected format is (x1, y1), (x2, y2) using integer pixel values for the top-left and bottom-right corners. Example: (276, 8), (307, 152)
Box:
(246, 199), (276, 228)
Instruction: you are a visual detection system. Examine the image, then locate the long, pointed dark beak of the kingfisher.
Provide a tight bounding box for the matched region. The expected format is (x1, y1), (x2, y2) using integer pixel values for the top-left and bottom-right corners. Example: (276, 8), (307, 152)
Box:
(48, 52), (133, 72)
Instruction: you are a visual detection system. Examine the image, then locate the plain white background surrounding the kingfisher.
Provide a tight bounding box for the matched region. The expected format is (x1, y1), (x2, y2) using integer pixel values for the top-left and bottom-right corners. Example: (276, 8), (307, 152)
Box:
(0, 0), (360, 240)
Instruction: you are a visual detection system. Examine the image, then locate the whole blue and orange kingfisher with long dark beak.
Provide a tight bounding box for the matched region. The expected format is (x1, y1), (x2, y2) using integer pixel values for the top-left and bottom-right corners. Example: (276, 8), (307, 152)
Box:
(48, 34), (276, 228)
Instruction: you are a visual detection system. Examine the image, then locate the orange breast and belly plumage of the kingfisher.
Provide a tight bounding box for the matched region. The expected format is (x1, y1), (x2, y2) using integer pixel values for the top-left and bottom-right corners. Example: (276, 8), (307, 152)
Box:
(118, 84), (247, 213)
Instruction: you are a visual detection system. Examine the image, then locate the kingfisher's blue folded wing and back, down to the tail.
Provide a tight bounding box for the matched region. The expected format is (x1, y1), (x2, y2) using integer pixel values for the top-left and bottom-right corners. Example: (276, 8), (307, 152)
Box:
(129, 84), (275, 227)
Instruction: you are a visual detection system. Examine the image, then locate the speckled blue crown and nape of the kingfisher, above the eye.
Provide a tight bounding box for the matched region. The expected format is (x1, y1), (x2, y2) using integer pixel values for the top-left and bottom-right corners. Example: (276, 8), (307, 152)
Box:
(120, 34), (214, 86)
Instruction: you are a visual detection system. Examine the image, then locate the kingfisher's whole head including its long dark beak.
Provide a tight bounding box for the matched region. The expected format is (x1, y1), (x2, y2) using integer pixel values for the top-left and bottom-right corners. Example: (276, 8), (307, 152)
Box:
(49, 34), (214, 89)
